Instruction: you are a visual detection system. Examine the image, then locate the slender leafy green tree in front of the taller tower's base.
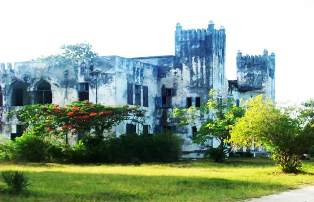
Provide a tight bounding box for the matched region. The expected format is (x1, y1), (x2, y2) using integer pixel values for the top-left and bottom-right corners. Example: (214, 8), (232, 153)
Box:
(174, 91), (244, 162)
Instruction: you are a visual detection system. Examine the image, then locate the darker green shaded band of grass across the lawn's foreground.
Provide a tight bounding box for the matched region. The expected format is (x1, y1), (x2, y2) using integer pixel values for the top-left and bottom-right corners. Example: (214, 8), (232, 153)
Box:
(0, 172), (290, 202)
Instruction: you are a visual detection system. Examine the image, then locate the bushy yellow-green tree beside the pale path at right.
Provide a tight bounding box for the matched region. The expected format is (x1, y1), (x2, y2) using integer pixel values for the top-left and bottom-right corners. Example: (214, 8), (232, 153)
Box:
(230, 96), (314, 173)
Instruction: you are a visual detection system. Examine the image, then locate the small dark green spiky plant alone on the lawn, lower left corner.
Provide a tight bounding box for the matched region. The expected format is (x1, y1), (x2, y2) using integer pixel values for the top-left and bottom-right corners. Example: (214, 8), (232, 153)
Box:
(2, 171), (29, 194)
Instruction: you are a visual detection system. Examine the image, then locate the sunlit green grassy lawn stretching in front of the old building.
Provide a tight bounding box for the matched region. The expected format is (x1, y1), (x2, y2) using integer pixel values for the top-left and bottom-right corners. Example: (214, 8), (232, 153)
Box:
(0, 159), (314, 202)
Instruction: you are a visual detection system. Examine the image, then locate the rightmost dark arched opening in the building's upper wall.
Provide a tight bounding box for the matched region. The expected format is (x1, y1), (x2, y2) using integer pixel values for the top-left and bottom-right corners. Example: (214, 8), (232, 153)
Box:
(34, 80), (52, 104)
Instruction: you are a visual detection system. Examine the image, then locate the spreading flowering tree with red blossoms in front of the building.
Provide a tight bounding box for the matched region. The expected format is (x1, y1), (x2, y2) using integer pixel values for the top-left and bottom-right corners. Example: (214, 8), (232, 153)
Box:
(14, 101), (144, 141)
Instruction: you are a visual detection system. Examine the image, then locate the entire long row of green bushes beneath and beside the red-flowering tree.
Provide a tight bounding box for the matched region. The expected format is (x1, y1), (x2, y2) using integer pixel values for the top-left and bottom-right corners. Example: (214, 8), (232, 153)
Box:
(4, 130), (182, 165)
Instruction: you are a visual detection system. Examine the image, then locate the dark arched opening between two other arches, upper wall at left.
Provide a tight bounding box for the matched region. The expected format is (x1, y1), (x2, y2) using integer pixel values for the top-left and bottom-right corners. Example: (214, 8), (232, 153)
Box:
(11, 81), (30, 106)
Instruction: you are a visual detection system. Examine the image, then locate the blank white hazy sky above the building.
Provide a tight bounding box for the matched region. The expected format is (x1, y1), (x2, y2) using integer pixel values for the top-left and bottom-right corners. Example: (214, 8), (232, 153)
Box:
(0, 0), (314, 102)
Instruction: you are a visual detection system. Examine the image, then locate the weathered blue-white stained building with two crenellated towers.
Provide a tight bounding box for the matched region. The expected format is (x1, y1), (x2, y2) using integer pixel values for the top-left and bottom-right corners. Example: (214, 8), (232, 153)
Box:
(0, 23), (275, 157)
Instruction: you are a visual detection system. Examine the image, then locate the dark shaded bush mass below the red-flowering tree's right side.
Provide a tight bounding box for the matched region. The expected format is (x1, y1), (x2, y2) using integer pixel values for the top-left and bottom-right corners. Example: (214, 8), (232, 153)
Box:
(68, 133), (182, 165)
